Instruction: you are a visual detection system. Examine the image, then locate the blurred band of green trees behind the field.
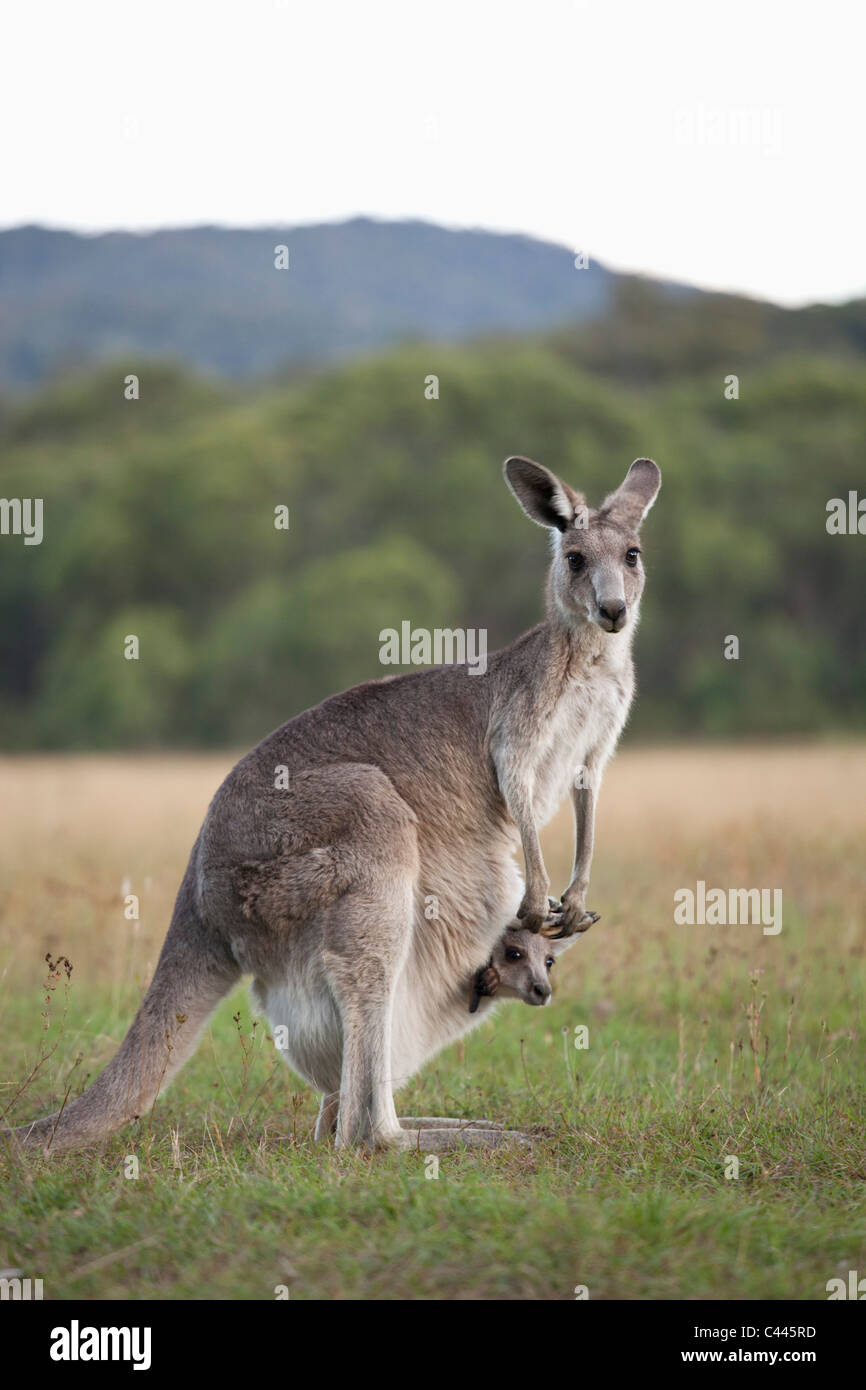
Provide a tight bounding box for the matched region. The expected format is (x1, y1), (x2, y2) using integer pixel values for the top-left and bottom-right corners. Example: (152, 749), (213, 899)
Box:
(0, 330), (866, 746)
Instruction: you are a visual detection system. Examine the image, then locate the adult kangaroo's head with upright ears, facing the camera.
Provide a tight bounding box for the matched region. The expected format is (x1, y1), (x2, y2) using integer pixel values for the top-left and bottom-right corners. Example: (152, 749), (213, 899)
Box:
(505, 459), (662, 632)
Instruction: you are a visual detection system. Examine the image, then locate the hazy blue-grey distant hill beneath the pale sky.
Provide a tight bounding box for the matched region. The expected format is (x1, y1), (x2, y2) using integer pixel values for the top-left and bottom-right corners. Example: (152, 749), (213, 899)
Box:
(0, 218), (699, 389)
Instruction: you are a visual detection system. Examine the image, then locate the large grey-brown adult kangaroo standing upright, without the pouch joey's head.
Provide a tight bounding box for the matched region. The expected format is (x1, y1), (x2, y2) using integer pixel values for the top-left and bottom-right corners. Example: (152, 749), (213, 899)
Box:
(6, 459), (660, 1152)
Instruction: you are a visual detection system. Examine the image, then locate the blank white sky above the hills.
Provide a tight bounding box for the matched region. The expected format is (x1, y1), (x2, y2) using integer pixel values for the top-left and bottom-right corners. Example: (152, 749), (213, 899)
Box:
(0, 0), (866, 304)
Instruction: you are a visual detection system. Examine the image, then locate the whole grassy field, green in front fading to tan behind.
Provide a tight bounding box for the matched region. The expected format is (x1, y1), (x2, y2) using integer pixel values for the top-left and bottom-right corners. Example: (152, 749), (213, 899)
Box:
(0, 745), (866, 1300)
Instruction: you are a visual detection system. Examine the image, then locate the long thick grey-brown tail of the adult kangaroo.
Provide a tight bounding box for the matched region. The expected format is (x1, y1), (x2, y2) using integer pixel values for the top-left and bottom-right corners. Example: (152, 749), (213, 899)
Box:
(0, 870), (240, 1155)
